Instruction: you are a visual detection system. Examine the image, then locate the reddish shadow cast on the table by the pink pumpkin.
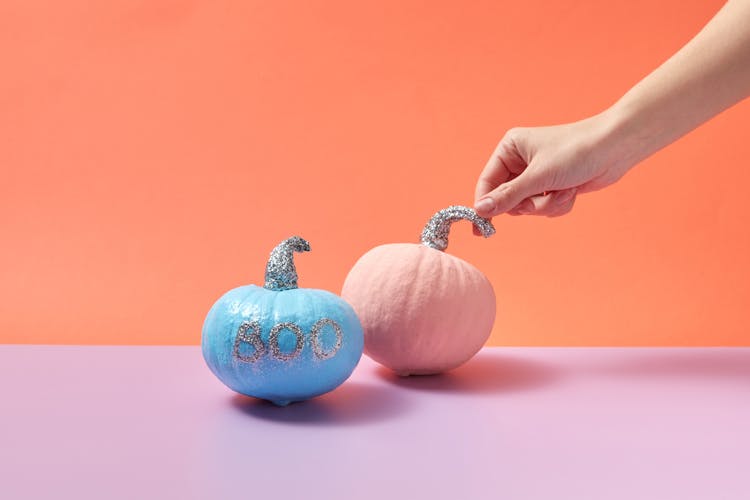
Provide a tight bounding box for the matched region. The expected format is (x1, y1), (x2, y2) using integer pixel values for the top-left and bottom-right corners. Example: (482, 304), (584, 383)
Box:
(375, 351), (563, 394)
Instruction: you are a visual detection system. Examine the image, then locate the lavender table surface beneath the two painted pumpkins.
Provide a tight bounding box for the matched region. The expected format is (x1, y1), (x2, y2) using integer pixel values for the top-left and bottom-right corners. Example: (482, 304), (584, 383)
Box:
(0, 345), (750, 500)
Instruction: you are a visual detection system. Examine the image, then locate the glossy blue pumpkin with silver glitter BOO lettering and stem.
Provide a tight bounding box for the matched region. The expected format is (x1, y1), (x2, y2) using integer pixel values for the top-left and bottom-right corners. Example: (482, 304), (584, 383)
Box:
(201, 236), (364, 406)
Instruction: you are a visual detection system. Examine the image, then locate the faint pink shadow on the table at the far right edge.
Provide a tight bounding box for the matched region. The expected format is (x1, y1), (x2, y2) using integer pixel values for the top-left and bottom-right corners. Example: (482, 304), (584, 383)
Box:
(599, 347), (750, 378)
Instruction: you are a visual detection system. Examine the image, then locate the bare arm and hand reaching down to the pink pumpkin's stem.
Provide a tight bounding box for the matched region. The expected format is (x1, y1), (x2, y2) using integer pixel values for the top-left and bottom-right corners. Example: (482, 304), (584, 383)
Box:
(475, 0), (750, 216)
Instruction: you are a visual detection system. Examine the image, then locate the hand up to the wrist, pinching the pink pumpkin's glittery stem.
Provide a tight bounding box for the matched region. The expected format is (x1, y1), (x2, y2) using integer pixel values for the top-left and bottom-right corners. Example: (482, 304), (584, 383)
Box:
(475, 114), (637, 217)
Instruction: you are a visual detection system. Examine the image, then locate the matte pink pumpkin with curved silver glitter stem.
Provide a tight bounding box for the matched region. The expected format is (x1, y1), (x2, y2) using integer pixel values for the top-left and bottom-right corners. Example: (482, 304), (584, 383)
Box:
(341, 206), (495, 376)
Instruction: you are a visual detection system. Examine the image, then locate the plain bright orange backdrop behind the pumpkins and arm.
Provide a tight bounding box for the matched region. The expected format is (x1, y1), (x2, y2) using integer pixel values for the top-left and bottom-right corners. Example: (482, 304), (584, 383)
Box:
(0, 0), (750, 345)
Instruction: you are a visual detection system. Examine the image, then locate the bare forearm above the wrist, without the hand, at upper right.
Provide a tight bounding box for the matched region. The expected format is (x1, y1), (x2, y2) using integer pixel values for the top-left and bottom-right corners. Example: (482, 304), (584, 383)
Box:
(603, 0), (750, 166)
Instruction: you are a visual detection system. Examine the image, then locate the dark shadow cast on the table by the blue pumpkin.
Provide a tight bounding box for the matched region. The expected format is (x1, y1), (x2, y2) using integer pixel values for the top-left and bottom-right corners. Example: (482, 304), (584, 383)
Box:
(232, 381), (409, 426)
